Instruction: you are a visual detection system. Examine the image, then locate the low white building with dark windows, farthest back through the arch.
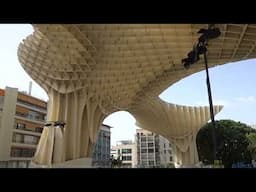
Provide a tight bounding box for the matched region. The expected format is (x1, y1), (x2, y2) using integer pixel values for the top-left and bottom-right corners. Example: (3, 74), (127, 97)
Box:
(111, 140), (137, 168)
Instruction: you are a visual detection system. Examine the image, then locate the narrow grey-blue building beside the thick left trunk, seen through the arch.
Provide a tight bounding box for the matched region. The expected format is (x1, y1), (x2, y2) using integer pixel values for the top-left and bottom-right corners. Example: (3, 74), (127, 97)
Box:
(92, 124), (111, 168)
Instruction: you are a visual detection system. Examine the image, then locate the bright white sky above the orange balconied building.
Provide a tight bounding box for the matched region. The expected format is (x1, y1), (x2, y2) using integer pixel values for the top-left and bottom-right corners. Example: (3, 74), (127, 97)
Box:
(0, 24), (48, 100)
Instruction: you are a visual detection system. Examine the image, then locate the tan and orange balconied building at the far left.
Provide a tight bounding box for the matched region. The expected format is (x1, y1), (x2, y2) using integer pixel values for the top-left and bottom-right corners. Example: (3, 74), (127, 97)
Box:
(0, 87), (47, 168)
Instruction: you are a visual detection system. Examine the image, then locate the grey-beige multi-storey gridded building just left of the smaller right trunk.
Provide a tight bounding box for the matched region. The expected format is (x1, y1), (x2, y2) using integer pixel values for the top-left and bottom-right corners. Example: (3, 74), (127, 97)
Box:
(136, 129), (173, 168)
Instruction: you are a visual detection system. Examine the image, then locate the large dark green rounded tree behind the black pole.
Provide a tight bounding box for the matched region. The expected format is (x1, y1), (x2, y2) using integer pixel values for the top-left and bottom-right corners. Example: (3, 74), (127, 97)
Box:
(196, 120), (255, 167)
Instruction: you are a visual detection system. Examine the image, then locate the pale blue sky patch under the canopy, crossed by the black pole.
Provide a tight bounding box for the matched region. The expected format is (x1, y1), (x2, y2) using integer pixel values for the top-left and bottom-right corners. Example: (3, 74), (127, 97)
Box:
(160, 59), (256, 124)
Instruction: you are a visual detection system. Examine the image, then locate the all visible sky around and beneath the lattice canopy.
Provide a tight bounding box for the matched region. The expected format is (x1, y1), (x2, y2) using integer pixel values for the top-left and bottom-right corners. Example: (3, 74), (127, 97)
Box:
(0, 24), (256, 145)
